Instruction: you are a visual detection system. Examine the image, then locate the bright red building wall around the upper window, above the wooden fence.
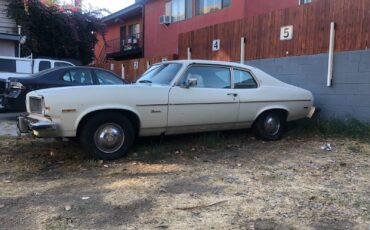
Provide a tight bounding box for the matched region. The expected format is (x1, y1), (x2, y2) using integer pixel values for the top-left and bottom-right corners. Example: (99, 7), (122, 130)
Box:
(144, 0), (298, 57)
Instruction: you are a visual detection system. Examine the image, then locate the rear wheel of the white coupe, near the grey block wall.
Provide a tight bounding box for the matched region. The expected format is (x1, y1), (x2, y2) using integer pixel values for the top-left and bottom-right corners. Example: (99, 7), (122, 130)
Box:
(254, 110), (285, 141)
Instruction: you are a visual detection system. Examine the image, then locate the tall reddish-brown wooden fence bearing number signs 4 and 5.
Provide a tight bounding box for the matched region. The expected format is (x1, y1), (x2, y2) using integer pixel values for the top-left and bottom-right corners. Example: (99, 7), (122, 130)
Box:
(179, 0), (370, 61)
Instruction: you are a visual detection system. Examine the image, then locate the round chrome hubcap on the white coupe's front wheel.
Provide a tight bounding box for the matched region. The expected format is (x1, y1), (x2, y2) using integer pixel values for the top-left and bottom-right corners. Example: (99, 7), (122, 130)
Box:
(94, 123), (125, 153)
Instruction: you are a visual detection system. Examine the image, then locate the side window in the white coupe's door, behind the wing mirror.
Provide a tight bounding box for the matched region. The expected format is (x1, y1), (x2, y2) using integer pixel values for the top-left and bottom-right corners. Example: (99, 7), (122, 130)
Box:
(181, 66), (231, 89)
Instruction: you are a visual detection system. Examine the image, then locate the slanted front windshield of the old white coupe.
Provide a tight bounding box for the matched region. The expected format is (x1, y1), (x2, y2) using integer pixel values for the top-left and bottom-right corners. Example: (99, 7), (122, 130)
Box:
(137, 63), (181, 85)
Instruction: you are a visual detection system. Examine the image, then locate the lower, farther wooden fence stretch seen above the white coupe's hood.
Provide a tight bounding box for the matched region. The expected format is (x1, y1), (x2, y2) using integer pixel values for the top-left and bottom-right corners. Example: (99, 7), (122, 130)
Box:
(94, 54), (178, 82)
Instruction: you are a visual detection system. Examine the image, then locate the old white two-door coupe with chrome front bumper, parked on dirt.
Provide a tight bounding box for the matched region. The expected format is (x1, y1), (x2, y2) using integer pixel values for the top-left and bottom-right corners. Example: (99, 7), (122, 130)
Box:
(18, 60), (315, 160)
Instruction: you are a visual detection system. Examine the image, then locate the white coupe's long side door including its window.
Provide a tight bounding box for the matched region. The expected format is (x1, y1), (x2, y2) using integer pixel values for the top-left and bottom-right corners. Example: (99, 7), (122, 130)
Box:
(167, 65), (239, 134)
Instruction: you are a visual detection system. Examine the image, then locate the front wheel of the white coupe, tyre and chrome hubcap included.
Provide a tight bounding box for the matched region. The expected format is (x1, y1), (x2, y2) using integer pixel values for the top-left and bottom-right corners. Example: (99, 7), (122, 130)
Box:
(80, 113), (135, 160)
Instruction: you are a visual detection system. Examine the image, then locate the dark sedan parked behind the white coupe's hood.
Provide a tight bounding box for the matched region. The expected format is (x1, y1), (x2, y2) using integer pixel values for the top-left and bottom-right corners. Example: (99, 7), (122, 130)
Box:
(0, 67), (126, 111)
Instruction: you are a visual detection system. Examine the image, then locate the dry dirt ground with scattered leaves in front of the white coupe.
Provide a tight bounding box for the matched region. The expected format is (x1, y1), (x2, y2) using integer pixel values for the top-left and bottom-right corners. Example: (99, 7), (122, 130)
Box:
(0, 132), (370, 230)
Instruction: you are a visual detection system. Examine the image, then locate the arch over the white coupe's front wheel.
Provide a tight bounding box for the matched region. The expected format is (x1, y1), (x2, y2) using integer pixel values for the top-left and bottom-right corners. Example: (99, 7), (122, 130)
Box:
(76, 109), (141, 137)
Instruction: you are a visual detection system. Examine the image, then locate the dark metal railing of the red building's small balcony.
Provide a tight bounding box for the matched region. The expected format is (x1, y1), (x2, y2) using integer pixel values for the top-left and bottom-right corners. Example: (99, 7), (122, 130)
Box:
(105, 34), (143, 53)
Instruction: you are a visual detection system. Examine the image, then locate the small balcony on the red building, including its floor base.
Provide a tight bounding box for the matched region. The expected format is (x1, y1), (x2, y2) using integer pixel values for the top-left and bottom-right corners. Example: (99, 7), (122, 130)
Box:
(105, 34), (143, 59)
